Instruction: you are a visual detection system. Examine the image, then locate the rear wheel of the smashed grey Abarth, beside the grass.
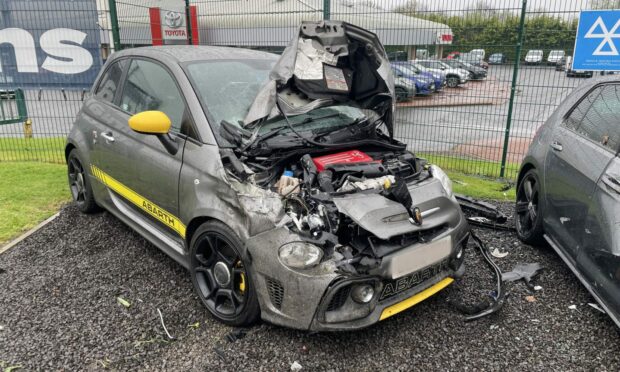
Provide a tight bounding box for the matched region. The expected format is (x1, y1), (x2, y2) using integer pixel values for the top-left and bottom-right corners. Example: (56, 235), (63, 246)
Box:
(67, 149), (100, 213)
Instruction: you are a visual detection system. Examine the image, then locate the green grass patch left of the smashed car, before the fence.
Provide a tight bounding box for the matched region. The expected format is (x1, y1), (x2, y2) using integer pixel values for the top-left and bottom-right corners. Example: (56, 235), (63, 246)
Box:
(0, 162), (70, 246)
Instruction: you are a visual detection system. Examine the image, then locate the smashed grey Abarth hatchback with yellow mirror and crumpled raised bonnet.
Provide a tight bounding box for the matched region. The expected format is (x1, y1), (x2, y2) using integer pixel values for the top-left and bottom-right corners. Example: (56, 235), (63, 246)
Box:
(66, 21), (470, 331)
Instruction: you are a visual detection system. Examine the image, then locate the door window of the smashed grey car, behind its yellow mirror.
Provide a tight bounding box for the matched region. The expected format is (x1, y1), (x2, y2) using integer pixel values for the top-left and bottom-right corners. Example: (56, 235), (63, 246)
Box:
(120, 59), (185, 132)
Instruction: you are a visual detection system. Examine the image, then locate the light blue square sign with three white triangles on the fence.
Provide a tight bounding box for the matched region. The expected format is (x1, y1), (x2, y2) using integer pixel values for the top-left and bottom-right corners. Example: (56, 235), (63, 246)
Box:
(573, 10), (620, 71)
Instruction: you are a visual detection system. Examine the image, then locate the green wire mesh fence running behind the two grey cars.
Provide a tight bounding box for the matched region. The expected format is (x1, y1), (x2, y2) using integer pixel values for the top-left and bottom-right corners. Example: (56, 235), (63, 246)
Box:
(0, 0), (604, 179)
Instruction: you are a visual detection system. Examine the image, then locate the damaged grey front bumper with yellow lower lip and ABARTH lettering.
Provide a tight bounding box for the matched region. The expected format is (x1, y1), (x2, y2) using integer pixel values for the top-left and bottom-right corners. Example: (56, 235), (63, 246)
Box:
(247, 211), (469, 331)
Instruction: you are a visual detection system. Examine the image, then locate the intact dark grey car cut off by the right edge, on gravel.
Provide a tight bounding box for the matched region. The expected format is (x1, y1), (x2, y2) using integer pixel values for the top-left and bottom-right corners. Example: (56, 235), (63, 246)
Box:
(516, 76), (620, 326)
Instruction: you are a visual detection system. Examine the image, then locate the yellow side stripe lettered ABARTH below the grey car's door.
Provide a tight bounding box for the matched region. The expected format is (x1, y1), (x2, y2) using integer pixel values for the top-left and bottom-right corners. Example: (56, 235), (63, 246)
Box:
(90, 164), (185, 238)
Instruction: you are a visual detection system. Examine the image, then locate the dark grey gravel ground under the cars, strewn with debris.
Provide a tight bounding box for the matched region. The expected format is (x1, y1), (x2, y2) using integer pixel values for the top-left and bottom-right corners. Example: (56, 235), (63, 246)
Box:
(0, 204), (620, 371)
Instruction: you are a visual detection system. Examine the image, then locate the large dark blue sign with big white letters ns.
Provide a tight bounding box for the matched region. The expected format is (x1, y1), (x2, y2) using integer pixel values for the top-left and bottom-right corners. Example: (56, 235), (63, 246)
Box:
(0, 0), (101, 89)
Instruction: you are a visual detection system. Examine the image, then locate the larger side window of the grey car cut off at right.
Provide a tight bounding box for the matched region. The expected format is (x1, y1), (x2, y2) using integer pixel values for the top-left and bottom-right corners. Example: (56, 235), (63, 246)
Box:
(577, 84), (620, 152)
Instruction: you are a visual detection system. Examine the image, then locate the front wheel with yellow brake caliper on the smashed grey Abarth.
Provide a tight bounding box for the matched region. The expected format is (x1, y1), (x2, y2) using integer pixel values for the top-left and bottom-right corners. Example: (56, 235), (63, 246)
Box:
(190, 221), (260, 327)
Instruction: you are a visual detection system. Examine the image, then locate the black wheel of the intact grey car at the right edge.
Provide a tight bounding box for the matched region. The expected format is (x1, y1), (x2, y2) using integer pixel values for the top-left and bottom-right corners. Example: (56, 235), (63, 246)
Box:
(515, 169), (544, 245)
